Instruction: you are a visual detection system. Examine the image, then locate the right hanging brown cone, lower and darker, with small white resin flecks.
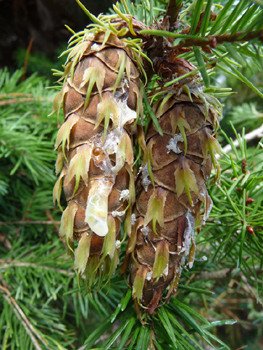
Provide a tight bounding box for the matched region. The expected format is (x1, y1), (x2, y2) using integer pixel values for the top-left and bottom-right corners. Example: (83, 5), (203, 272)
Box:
(126, 59), (220, 314)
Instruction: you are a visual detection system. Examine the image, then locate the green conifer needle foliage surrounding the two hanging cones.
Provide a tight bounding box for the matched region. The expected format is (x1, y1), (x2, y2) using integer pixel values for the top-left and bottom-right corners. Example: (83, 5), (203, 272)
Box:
(0, 0), (263, 350)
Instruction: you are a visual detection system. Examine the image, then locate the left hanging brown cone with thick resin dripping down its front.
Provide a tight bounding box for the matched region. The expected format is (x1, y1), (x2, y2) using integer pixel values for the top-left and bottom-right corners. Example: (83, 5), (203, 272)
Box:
(54, 29), (142, 287)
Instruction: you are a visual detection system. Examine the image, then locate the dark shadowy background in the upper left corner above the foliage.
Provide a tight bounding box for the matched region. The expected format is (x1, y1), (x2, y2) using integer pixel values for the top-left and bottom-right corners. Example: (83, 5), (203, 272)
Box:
(0, 0), (113, 79)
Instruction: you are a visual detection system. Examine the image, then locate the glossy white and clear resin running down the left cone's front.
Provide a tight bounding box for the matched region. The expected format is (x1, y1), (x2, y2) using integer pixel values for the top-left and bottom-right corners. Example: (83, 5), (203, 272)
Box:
(85, 92), (138, 238)
